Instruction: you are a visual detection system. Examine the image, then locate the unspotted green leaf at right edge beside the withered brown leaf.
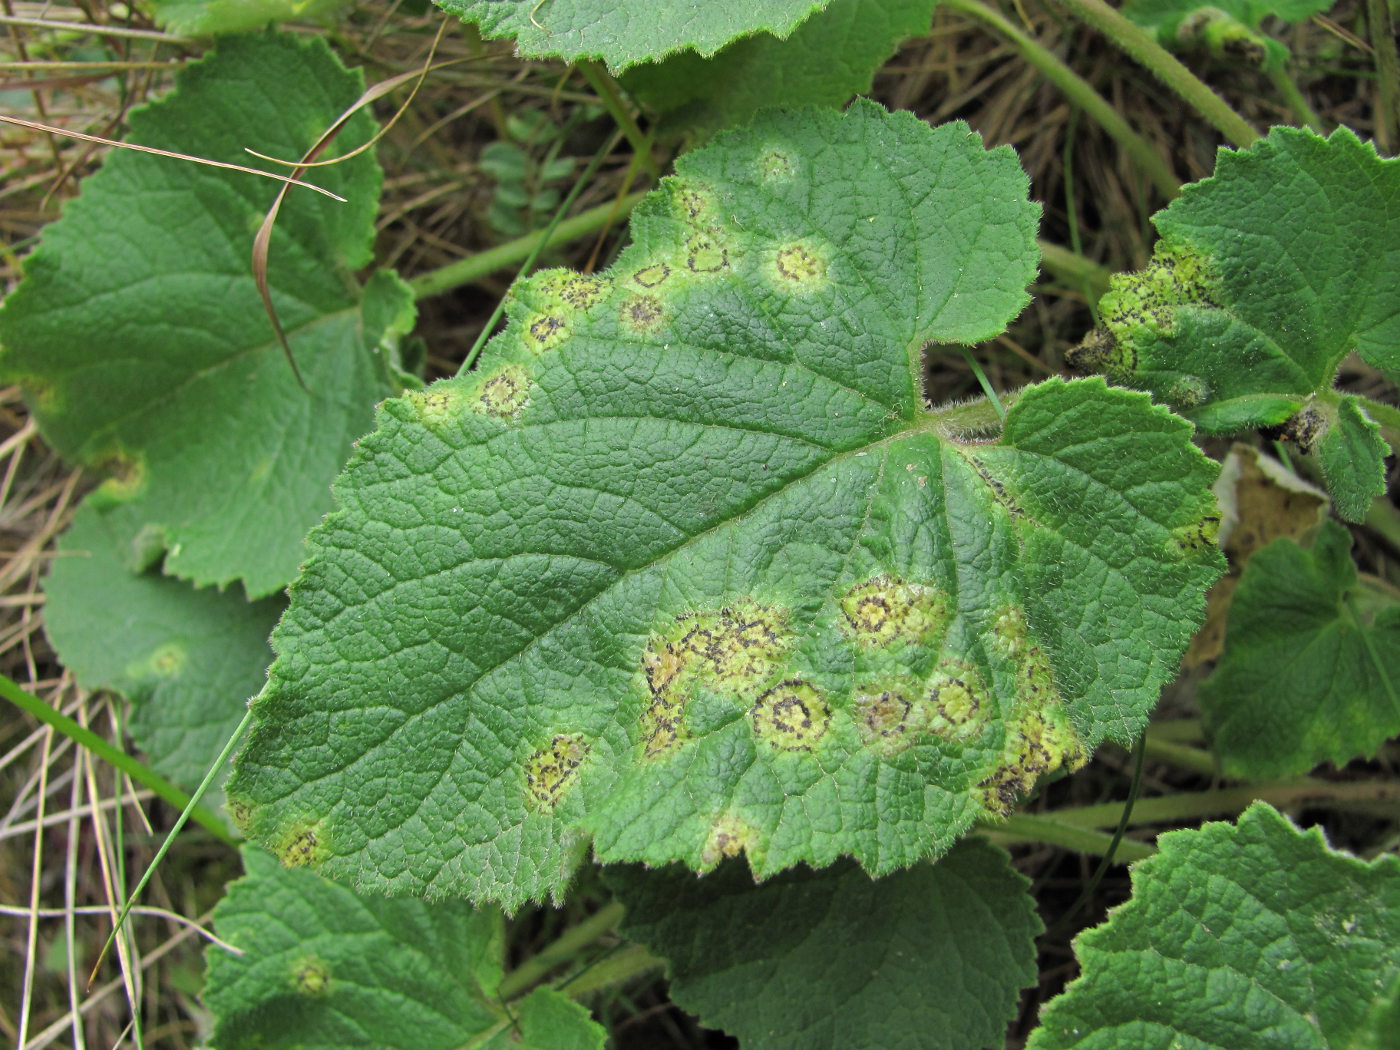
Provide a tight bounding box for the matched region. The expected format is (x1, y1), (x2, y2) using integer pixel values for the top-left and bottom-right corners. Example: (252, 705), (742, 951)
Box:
(1200, 521), (1400, 778)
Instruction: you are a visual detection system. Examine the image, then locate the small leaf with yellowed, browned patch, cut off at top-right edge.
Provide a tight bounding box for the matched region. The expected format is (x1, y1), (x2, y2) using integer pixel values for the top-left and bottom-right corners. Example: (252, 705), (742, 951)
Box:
(1123, 0), (1333, 69)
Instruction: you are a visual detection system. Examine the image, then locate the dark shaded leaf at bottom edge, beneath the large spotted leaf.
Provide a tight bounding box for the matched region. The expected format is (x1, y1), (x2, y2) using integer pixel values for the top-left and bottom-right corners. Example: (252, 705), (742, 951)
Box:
(608, 839), (1042, 1050)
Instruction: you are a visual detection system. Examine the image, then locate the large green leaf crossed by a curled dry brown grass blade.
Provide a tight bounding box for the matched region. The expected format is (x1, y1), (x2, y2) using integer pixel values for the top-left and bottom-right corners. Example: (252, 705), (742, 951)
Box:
(0, 35), (413, 596)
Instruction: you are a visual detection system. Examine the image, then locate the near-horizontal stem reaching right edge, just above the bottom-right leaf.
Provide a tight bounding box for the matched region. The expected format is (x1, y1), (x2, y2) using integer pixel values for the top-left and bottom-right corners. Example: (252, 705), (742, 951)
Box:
(1054, 777), (1400, 827)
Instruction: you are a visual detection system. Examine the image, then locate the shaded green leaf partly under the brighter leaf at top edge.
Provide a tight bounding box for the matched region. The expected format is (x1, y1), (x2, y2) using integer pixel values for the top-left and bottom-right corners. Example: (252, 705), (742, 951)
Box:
(623, 0), (934, 132)
